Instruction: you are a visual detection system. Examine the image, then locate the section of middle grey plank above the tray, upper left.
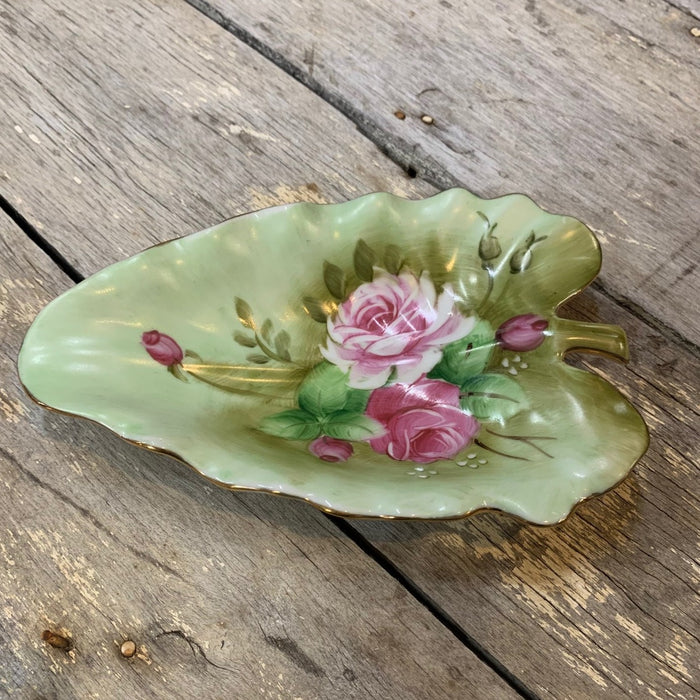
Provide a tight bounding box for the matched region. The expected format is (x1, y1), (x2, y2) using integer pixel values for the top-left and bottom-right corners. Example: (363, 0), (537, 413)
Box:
(0, 0), (433, 273)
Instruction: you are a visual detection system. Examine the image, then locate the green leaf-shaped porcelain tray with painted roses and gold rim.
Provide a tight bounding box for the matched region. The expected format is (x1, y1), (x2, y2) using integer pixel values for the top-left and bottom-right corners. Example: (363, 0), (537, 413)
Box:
(19, 189), (648, 524)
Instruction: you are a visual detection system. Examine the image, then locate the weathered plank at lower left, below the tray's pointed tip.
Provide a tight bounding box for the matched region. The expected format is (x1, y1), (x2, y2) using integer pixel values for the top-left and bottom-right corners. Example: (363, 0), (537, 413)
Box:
(0, 215), (517, 699)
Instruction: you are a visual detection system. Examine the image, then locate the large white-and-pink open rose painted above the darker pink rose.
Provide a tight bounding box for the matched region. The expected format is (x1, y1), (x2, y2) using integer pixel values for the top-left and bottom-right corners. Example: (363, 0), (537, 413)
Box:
(321, 270), (475, 389)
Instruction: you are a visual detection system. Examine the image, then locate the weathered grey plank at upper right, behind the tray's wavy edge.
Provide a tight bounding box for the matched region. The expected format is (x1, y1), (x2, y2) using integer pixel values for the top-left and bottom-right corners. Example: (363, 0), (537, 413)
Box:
(198, 0), (700, 343)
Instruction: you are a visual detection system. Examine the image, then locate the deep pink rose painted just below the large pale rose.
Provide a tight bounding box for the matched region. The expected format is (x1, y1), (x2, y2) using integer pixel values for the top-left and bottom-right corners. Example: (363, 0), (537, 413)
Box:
(367, 379), (479, 463)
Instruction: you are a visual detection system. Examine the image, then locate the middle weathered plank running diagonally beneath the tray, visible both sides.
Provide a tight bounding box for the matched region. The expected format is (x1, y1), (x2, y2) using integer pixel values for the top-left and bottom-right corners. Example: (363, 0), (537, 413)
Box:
(0, 2), (697, 698)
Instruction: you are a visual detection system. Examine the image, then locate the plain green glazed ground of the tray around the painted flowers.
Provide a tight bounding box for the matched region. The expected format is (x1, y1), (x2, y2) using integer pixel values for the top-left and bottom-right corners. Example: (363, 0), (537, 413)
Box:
(19, 189), (648, 523)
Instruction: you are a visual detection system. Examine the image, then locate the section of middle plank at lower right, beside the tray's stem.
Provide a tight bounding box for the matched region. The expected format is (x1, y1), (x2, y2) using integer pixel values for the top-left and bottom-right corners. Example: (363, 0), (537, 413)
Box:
(357, 290), (700, 700)
